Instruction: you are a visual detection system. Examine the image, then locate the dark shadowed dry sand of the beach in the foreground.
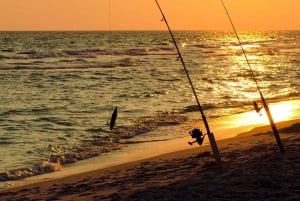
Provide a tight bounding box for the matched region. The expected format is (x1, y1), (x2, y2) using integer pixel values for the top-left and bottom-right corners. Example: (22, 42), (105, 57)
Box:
(0, 120), (300, 201)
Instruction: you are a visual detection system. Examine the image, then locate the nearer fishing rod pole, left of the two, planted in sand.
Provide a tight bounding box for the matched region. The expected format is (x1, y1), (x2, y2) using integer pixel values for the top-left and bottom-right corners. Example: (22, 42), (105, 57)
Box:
(155, 0), (222, 167)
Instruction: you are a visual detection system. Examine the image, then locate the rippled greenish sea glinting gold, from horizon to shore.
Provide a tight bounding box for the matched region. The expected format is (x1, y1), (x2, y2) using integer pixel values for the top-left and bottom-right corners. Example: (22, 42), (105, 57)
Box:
(0, 31), (300, 181)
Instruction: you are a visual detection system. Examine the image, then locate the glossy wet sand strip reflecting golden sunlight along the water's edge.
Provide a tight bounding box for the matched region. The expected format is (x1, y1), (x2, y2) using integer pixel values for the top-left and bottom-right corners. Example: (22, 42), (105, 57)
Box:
(0, 99), (300, 191)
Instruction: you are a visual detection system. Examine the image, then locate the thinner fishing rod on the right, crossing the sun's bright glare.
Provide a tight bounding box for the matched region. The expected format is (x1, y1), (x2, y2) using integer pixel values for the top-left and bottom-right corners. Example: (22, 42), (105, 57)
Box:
(220, 0), (285, 153)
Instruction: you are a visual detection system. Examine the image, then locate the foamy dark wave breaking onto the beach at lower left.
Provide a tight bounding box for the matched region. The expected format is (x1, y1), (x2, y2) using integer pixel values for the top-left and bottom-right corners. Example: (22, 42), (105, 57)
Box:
(0, 113), (187, 181)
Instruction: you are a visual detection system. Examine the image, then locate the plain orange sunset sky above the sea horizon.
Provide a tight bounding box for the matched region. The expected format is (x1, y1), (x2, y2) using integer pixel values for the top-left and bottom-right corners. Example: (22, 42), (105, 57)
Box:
(0, 0), (300, 31)
